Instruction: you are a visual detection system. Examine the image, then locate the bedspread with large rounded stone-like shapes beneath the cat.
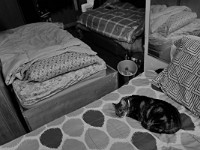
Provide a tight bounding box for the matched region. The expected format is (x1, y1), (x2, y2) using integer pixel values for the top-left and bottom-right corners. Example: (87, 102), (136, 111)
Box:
(0, 71), (200, 150)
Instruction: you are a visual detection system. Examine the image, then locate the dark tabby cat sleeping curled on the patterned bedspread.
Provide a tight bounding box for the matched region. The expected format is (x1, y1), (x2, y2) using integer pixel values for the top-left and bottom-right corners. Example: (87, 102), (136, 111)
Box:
(113, 95), (181, 134)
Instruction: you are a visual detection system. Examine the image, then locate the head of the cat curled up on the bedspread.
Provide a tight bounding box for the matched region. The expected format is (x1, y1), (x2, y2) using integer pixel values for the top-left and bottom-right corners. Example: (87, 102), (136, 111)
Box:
(113, 97), (129, 117)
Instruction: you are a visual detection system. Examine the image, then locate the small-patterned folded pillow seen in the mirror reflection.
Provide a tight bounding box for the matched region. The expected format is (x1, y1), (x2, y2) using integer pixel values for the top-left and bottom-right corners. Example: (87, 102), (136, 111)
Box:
(157, 11), (197, 37)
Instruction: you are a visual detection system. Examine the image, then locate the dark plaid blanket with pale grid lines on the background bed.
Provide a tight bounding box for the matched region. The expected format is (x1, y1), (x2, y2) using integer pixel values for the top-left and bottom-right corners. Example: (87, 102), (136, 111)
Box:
(77, 2), (145, 43)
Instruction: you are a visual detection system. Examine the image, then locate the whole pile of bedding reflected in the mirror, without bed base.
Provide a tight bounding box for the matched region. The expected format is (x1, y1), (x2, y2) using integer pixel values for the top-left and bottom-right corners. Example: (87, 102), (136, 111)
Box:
(149, 5), (200, 44)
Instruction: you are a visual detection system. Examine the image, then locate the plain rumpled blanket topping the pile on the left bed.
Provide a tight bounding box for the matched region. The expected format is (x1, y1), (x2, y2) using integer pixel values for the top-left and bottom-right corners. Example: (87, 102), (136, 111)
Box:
(0, 22), (96, 84)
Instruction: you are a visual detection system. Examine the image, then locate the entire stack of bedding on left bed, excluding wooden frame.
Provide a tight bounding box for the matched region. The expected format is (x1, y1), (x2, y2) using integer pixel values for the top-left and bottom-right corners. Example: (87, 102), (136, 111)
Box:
(0, 22), (106, 108)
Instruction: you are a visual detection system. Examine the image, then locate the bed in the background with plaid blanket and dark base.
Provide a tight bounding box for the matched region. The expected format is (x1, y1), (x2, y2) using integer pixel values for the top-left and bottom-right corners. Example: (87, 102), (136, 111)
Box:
(77, 0), (145, 72)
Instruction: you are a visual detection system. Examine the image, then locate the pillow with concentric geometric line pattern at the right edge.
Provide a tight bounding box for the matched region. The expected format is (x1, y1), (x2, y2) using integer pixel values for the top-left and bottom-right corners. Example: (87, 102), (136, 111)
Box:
(152, 36), (200, 116)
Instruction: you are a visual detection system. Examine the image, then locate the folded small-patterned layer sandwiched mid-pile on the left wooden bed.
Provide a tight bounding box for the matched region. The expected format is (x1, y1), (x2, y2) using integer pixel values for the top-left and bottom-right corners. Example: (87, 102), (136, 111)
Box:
(16, 52), (98, 82)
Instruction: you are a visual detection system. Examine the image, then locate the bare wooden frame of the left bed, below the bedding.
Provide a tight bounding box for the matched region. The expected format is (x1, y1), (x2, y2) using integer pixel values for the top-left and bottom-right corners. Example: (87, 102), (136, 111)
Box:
(0, 66), (118, 131)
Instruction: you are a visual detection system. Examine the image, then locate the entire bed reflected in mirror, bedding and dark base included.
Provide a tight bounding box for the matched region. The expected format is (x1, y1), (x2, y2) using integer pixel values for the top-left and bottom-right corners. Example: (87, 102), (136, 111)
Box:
(149, 4), (200, 63)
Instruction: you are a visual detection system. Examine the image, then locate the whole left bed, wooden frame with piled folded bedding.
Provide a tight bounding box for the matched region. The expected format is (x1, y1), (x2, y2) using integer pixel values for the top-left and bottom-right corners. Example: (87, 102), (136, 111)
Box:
(0, 22), (117, 130)
